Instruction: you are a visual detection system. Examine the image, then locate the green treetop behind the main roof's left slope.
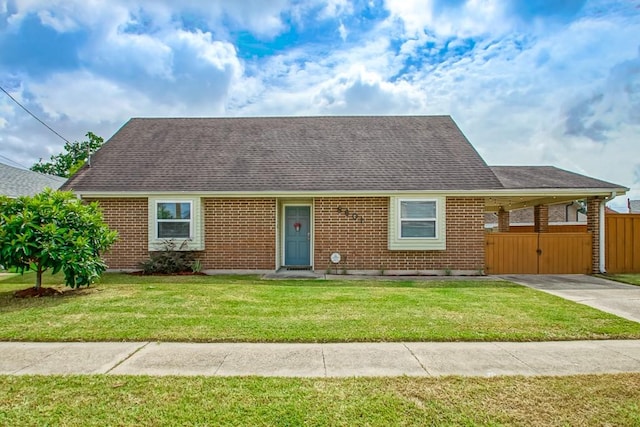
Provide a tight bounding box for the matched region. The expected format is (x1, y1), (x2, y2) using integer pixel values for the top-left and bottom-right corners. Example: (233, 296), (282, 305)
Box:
(30, 132), (104, 178)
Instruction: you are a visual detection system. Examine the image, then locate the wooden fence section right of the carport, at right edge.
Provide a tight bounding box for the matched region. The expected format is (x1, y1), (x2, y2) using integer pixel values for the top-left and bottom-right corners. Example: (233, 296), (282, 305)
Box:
(605, 213), (640, 274)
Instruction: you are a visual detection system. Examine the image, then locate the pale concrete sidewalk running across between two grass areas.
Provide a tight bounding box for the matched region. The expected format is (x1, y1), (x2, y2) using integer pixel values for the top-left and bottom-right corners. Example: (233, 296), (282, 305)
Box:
(0, 340), (640, 377)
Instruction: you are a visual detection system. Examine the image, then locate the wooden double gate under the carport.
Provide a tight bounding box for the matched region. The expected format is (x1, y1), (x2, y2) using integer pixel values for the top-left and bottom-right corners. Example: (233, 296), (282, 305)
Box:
(485, 233), (592, 274)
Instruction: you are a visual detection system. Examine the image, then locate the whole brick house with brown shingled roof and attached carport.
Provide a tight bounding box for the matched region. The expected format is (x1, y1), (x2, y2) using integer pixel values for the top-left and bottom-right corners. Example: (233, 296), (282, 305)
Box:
(63, 116), (627, 274)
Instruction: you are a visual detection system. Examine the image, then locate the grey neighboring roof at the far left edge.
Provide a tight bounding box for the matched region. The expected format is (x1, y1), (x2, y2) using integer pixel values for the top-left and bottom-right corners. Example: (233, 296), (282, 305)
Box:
(0, 163), (66, 197)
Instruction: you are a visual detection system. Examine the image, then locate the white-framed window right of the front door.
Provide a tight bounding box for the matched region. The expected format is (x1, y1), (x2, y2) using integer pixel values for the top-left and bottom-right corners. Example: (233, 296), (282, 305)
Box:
(398, 199), (438, 239)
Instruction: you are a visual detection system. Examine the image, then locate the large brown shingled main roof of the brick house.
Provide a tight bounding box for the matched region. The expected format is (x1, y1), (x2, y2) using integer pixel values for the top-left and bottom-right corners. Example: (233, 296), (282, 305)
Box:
(65, 116), (502, 192)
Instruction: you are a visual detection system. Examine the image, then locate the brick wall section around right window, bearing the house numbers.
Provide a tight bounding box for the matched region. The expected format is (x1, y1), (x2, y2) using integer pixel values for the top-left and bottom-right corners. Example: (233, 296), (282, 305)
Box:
(314, 197), (484, 271)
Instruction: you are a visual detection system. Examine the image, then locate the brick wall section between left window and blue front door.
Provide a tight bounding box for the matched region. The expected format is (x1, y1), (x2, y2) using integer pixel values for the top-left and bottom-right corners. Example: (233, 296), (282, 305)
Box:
(201, 198), (276, 270)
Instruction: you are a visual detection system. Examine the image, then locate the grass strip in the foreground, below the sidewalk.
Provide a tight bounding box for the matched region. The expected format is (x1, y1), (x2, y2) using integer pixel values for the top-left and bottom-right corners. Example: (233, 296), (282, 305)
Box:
(0, 374), (640, 426)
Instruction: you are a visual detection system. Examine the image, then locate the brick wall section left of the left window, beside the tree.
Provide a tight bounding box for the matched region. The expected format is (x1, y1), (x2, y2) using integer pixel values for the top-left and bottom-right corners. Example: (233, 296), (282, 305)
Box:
(85, 198), (149, 269)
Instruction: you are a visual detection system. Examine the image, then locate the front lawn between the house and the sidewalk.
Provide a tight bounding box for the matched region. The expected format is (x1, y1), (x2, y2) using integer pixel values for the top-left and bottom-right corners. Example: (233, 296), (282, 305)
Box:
(0, 274), (640, 342)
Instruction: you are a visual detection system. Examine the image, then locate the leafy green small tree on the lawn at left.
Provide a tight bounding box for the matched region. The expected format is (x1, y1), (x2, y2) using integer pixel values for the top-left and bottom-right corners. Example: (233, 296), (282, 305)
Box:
(0, 189), (117, 289)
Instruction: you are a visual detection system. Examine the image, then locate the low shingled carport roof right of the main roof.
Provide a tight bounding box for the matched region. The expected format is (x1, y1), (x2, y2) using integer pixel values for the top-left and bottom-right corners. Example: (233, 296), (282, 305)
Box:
(491, 166), (620, 189)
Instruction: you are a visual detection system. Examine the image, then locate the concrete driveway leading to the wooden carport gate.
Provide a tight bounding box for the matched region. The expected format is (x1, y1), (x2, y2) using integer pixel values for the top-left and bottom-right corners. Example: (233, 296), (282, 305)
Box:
(500, 274), (640, 322)
